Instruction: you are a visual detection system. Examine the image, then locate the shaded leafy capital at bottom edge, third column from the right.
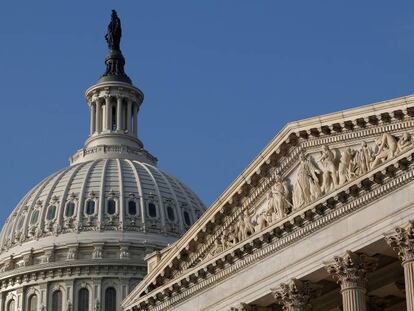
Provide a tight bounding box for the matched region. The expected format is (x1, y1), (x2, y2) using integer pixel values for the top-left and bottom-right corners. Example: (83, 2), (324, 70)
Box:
(272, 279), (315, 311)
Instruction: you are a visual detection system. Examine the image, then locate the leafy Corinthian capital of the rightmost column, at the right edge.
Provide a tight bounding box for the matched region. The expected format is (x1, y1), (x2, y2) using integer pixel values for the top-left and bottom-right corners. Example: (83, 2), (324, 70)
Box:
(385, 221), (414, 262)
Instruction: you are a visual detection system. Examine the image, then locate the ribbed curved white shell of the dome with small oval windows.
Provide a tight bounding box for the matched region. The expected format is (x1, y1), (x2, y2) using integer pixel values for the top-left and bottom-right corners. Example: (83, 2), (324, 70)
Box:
(0, 159), (205, 251)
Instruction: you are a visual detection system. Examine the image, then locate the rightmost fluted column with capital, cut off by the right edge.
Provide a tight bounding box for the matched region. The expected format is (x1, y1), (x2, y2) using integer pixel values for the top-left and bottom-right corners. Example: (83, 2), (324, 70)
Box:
(385, 221), (414, 311)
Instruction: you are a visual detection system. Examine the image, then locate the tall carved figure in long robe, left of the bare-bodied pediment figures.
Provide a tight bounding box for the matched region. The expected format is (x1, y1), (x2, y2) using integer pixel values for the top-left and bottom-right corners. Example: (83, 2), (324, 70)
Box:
(292, 154), (321, 210)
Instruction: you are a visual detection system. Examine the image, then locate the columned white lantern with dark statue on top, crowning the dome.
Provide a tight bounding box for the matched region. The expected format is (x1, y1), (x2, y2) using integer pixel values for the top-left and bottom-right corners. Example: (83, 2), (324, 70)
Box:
(70, 10), (157, 165)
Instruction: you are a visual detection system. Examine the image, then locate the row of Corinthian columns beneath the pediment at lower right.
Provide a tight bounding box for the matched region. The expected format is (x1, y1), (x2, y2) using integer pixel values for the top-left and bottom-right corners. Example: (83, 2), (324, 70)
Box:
(230, 221), (414, 311)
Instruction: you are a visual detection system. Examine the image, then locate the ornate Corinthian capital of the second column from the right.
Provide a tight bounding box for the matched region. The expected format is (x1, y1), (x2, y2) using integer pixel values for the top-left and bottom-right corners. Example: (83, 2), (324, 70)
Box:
(326, 251), (377, 289)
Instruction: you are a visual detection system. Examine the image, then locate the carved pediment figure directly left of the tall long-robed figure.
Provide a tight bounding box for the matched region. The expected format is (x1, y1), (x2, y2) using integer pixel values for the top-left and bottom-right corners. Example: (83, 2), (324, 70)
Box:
(267, 174), (290, 223)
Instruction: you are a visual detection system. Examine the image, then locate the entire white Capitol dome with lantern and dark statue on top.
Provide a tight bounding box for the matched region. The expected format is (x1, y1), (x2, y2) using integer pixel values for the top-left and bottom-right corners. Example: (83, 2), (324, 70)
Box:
(0, 11), (205, 311)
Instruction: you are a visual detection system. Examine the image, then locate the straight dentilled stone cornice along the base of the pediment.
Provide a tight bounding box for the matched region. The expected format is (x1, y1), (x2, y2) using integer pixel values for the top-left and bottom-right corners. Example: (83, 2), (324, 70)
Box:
(123, 143), (414, 311)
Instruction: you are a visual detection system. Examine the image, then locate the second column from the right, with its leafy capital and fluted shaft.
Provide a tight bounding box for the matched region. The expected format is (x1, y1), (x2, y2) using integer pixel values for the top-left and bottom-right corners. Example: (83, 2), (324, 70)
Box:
(326, 251), (377, 311)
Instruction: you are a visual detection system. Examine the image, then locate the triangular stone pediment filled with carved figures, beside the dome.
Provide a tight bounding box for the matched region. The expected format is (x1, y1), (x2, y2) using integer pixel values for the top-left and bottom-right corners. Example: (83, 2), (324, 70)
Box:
(123, 96), (414, 307)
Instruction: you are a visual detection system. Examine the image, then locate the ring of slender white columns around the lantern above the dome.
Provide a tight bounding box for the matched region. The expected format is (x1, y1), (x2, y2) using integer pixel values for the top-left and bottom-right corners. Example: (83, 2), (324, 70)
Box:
(90, 96), (138, 136)
